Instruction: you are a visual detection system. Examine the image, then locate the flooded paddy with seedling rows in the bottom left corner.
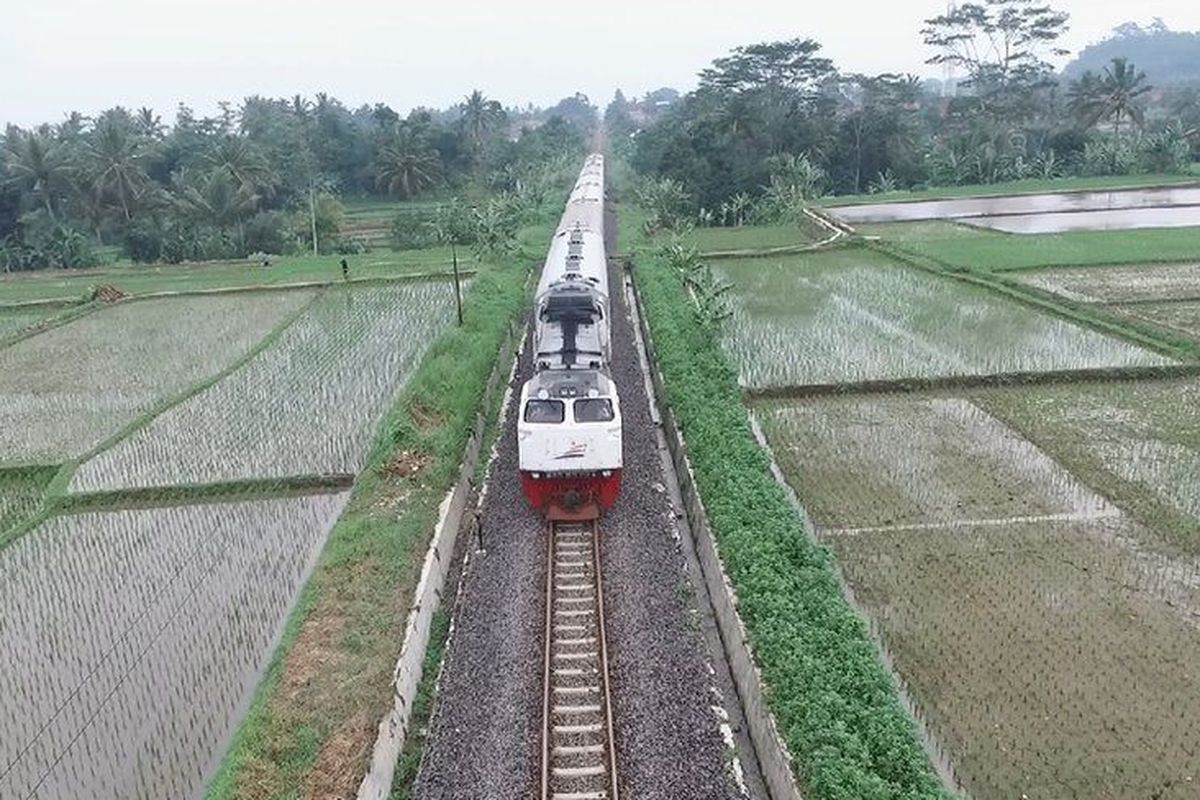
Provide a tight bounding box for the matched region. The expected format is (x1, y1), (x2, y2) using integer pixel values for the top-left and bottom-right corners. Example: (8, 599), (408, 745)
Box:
(0, 494), (347, 800)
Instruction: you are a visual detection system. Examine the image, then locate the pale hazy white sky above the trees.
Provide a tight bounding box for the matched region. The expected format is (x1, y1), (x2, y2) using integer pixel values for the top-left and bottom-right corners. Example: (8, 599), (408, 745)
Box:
(7, 0), (1200, 125)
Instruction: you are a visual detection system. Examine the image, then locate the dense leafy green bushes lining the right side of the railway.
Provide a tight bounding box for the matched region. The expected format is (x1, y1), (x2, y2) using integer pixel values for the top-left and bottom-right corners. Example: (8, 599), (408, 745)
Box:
(636, 250), (952, 800)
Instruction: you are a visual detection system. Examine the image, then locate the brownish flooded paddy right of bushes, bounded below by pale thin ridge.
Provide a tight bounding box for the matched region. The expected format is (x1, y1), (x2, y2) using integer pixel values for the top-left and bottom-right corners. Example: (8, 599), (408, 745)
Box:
(757, 396), (1117, 530)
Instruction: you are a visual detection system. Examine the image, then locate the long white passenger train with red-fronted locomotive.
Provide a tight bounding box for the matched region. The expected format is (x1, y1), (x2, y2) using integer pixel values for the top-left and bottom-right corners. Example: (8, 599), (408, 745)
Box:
(517, 154), (622, 521)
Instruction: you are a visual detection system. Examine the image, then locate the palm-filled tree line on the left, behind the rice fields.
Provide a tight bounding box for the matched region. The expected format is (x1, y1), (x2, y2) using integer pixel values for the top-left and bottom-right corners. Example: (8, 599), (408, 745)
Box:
(0, 91), (596, 271)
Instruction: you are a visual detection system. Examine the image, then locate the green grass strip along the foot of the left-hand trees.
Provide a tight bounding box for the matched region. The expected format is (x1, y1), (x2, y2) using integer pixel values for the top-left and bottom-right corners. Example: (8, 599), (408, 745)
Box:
(0, 247), (458, 306)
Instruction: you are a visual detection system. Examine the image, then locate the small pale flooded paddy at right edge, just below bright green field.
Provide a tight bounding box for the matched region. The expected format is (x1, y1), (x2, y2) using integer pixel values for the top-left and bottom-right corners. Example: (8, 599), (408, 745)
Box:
(1019, 263), (1200, 302)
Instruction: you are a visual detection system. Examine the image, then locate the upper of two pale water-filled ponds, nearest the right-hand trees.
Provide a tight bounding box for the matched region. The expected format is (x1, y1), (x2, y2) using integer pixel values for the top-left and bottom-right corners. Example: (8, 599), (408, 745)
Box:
(829, 186), (1200, 224)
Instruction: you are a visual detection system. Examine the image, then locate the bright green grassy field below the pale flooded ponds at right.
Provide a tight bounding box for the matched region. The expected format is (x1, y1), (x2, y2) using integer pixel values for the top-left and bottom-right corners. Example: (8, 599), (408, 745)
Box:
(858, 221), (1200, 271)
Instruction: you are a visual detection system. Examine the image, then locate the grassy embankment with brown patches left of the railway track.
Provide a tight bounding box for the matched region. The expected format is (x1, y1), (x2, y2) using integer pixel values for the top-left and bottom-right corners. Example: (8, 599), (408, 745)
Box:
(205, 236), (535, 800)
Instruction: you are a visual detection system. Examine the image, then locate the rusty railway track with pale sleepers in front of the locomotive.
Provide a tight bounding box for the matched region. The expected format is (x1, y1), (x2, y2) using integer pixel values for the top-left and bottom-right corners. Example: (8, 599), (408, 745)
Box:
(541, 521), (618, 800)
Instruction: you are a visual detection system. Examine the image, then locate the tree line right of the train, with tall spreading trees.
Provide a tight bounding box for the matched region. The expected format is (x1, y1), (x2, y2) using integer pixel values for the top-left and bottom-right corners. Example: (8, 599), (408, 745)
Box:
(619, 0), (1200, 224)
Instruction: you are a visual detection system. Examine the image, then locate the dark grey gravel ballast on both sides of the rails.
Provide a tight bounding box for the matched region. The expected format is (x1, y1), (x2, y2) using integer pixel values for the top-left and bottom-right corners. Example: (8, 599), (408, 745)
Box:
(414, 206), (740, 800)
